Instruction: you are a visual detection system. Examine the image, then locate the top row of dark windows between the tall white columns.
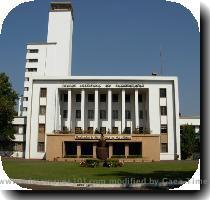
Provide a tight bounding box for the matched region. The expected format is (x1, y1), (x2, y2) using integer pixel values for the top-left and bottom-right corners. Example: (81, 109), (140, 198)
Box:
(60, 93), (142, 103)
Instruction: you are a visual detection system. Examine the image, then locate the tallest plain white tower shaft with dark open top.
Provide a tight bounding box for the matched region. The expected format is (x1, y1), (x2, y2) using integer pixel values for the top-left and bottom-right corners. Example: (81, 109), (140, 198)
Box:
(46, 2), (73, 76)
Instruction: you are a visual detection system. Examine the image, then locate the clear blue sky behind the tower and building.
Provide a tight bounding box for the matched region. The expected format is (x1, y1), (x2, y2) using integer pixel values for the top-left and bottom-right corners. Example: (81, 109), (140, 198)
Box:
(0, 0), (200, 116)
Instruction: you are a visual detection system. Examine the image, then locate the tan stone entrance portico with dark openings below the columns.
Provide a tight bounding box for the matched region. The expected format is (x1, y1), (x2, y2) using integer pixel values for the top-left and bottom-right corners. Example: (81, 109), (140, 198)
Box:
(46, 134), (160, 162)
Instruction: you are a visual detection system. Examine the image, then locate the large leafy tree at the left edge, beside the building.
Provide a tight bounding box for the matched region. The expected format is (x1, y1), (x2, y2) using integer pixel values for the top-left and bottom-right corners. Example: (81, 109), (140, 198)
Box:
(0, 73), (18, 149)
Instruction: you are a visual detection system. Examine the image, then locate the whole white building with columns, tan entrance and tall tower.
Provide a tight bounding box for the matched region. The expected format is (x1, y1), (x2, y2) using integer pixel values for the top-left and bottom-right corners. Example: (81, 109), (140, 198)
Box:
(9, 2), (199, 161)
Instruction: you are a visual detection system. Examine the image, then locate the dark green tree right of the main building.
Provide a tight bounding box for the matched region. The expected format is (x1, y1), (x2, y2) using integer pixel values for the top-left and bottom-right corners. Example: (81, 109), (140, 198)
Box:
(181, 125), (198, 159)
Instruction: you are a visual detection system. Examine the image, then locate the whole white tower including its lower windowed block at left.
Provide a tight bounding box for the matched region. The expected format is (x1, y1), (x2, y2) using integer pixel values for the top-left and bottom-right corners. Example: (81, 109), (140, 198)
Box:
(19, 2), (73, 116)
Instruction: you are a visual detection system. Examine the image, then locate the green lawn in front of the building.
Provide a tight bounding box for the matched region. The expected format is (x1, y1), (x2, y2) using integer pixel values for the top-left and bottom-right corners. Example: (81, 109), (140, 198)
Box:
(3, 159), (198, 183)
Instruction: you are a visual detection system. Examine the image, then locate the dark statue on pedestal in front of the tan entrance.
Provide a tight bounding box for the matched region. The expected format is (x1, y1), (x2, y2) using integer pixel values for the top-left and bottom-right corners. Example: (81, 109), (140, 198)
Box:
(96, 133), (109, 160)
